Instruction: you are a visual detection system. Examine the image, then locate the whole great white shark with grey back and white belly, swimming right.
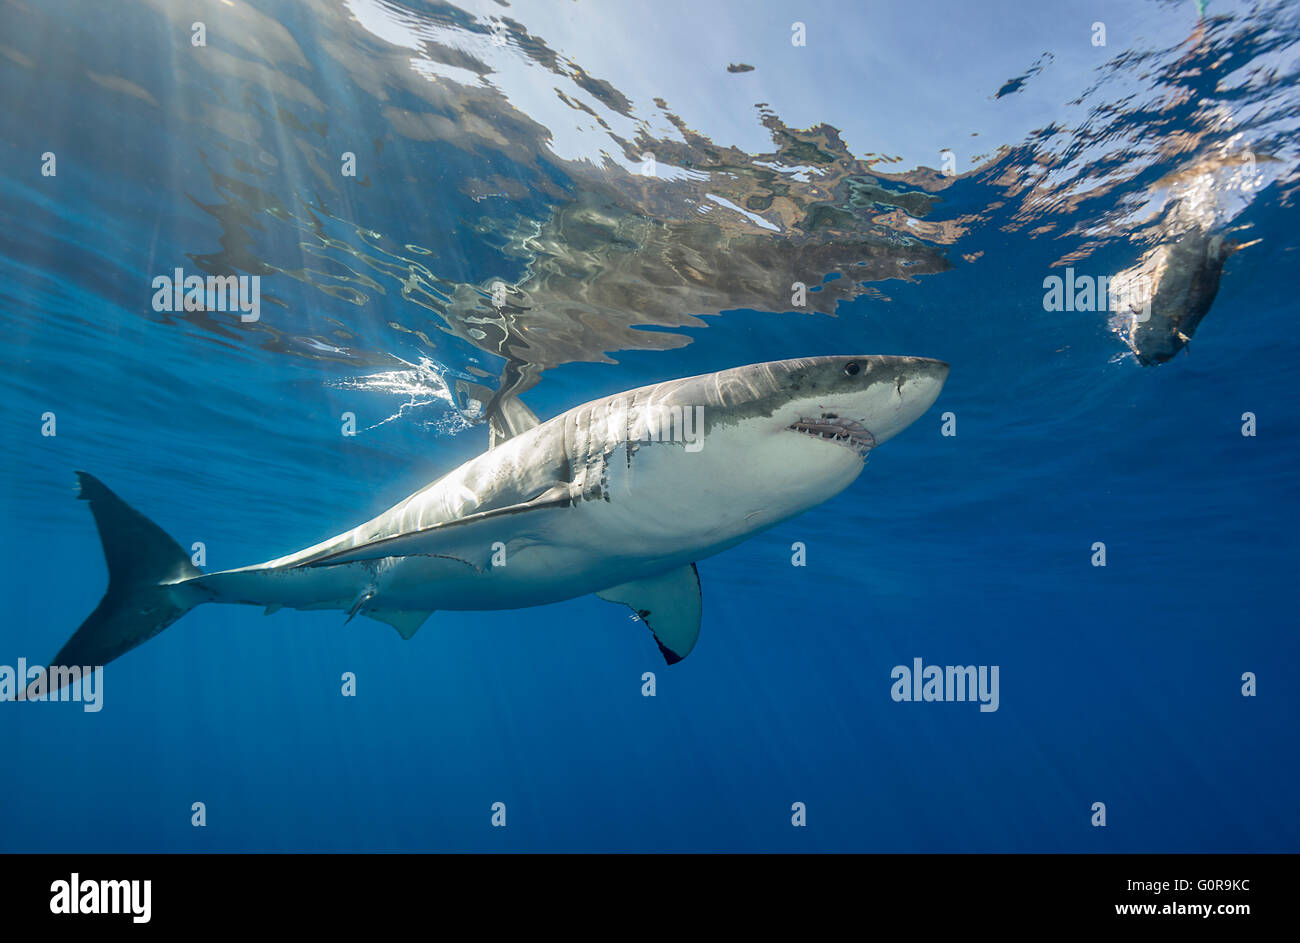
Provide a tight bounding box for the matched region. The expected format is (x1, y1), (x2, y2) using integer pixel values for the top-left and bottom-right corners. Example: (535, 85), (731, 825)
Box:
(29, 356), (948, 691)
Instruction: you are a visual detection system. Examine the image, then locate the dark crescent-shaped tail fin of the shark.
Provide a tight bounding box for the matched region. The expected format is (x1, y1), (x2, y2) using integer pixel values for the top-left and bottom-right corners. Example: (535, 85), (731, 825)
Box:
(25, 472), (203, 695)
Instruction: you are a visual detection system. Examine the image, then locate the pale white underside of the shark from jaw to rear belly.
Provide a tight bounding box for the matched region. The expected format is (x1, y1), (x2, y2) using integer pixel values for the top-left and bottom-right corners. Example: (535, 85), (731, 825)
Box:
(390, 431), (863, 609)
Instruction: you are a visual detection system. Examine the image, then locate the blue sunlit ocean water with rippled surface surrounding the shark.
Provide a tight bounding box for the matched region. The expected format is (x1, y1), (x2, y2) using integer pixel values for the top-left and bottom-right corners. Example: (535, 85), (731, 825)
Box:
(0, 0), (1300, 852)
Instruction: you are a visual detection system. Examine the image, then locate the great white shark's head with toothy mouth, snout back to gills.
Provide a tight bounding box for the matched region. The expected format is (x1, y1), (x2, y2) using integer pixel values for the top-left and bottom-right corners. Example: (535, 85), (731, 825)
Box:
(587, 356), (948, 558)
